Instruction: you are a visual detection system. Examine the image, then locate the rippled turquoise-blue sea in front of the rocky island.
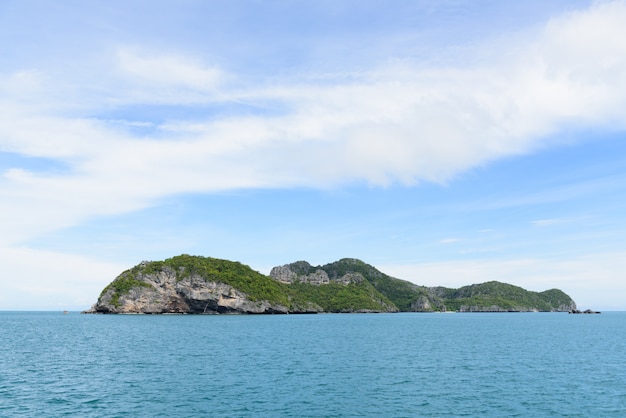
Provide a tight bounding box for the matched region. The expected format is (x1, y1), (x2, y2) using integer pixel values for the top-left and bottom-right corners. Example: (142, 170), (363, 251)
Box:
(0, 312), (626, 417)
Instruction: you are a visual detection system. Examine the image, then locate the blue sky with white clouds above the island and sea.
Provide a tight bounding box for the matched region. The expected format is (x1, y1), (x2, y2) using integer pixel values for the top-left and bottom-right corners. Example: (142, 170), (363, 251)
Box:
(0, 0), (626, 310)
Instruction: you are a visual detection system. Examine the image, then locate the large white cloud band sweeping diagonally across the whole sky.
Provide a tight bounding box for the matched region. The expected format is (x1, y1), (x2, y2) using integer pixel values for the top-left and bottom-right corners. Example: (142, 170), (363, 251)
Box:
(0, 1), (626, 308)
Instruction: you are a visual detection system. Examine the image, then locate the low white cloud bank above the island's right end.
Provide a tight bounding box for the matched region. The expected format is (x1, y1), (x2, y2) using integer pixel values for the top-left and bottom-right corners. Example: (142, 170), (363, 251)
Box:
(377, 252), (626, 310)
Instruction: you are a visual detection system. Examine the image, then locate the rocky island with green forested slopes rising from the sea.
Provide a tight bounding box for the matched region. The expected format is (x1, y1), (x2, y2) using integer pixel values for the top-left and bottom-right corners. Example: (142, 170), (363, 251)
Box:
(85, 255), (576, 314)
